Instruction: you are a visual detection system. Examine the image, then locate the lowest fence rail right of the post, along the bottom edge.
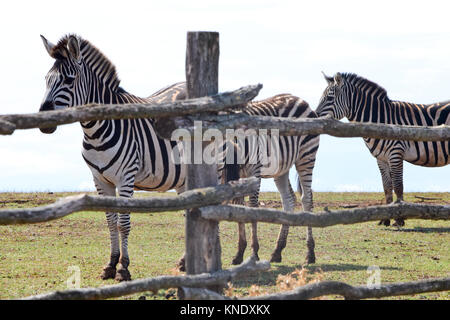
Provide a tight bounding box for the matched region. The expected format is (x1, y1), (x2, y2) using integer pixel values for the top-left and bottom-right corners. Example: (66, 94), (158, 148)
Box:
(247, 278), (450, 300)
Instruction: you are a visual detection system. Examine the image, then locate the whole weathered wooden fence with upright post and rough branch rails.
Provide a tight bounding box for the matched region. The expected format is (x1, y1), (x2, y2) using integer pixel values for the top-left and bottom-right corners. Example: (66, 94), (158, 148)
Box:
(0, 32), (450, 299)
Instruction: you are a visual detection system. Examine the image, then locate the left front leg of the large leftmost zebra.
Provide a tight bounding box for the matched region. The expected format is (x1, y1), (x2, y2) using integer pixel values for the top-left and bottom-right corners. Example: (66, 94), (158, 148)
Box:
(94, 178), (120, 280)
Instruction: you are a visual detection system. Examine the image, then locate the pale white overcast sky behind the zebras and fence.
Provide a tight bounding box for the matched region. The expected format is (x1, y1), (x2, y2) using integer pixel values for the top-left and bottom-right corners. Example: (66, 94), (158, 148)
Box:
(0, 0), (450, 192)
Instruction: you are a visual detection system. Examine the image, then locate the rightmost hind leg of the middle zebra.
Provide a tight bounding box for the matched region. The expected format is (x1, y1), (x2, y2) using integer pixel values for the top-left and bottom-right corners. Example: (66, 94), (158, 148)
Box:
(296, 159), (316, 264)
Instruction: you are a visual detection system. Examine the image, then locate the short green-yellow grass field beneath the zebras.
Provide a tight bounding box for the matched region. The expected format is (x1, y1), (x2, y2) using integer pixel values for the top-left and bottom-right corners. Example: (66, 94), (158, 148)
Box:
(0, 193), (450, 299)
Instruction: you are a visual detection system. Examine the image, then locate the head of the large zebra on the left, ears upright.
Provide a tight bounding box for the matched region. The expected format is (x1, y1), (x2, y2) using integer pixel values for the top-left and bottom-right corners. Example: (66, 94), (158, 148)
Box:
(39, 35), (85, 133)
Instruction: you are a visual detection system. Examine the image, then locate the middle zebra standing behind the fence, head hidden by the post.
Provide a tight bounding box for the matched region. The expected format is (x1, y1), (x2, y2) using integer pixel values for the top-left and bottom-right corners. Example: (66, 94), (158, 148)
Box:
(224, 94), (319, 264)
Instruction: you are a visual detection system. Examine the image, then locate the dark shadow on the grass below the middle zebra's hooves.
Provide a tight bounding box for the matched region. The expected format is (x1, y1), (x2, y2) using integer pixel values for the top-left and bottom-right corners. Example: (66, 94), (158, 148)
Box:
(233, 263), (400, 288)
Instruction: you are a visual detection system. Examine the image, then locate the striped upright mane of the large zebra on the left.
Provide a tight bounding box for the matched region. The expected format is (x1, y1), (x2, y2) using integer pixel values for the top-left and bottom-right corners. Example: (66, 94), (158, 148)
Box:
(52, 34), (120, 89)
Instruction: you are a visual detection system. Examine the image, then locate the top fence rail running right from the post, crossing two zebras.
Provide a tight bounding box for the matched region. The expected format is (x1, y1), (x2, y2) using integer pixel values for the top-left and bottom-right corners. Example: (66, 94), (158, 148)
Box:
(173, 114), (450, 141)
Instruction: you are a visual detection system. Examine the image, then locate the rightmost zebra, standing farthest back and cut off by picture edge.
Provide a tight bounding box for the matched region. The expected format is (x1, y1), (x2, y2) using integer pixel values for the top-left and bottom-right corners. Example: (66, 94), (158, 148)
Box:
(316, 73), (450, 226)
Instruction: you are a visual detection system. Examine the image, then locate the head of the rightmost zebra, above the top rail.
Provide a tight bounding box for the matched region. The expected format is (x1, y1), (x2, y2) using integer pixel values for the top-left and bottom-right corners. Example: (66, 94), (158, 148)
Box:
(316, 73), (350, 120)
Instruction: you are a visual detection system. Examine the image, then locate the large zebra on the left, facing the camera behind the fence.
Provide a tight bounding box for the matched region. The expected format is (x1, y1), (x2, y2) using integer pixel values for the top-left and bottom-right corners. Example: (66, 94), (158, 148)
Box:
(40, 35), (186, 281)
